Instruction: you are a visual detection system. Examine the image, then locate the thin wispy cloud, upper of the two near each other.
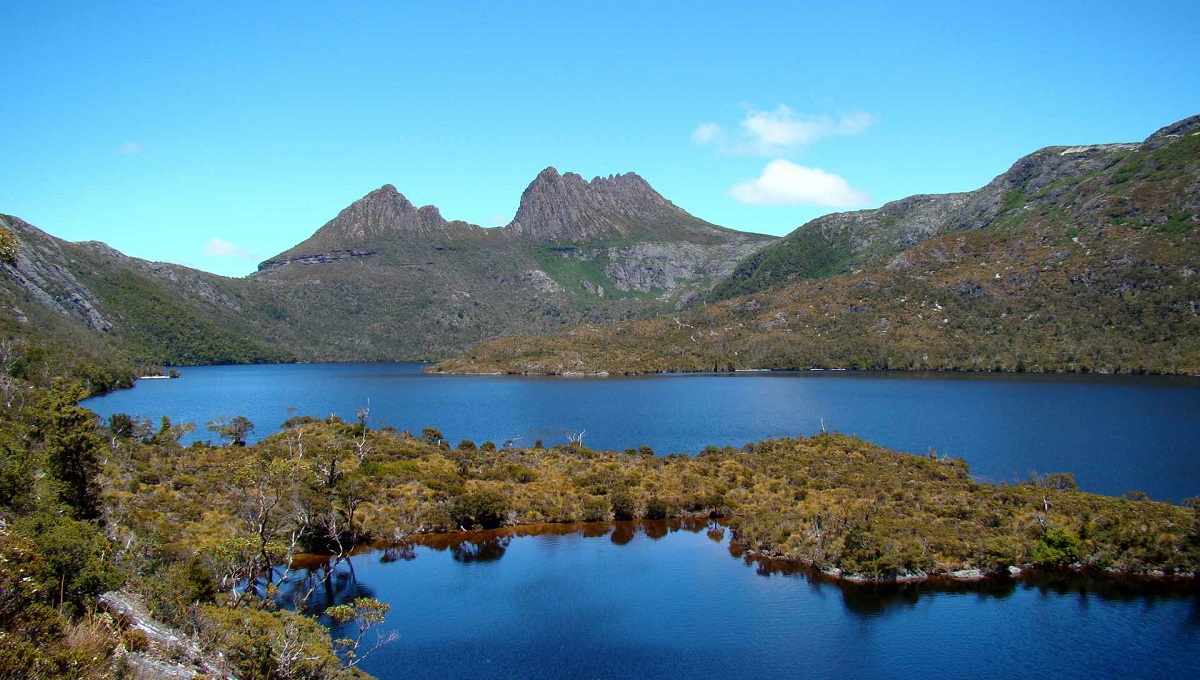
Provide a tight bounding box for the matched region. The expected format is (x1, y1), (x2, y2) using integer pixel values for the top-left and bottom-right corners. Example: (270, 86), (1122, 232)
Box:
(691, 104), (877, 156)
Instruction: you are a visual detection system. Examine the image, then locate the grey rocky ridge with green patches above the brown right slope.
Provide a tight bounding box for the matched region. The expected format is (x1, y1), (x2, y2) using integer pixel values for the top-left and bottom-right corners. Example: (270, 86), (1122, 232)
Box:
(709, 116), (1200, 300)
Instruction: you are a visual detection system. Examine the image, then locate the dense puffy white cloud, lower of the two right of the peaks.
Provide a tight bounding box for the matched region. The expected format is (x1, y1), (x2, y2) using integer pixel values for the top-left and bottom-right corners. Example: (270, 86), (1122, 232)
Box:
(730, 158), (871, 207)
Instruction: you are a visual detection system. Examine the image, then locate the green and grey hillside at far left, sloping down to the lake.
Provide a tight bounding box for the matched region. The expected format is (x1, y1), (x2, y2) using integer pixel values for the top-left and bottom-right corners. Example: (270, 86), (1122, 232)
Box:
(0, 216), (295, 374)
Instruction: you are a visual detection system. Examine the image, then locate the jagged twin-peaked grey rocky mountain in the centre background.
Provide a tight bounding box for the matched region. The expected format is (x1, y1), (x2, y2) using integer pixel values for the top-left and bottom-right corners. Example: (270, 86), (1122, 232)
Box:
(252, 168), (774, 359)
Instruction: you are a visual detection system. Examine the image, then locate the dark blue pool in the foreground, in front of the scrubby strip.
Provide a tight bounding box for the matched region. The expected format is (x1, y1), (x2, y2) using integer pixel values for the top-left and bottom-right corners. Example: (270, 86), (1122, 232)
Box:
(278, 522), (1200, 680)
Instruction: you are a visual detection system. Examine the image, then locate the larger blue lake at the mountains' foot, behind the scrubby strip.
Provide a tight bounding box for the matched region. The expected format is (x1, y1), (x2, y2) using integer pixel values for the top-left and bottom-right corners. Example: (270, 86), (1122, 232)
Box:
(84, 363), (1200, 501)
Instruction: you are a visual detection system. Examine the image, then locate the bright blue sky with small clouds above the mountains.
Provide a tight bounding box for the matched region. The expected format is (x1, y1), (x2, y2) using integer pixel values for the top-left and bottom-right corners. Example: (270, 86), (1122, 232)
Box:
(0, 1), (1200, 276)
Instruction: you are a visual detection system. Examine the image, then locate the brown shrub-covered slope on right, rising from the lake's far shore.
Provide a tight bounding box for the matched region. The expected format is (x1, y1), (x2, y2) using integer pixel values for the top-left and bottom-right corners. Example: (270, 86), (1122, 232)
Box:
(437, 119), (1200, 374)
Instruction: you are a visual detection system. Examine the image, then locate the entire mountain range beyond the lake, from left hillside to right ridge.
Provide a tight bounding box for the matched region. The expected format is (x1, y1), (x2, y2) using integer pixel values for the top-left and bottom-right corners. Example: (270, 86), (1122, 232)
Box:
(0, 116), (1200, 390)
